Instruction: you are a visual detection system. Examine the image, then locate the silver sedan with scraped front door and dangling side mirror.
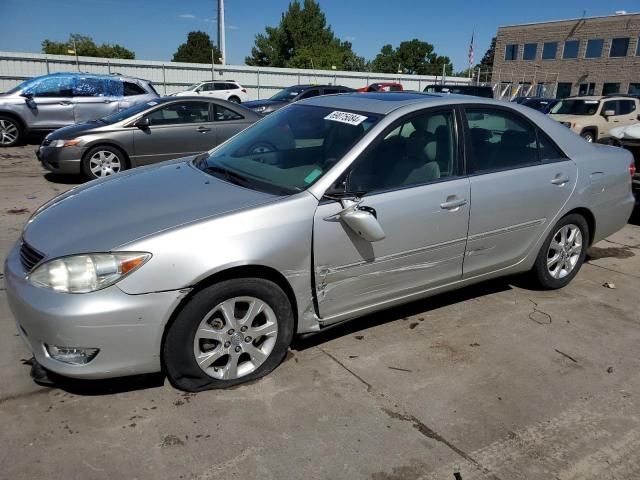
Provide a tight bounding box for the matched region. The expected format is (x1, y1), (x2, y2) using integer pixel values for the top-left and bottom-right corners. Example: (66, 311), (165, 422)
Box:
(5, 93), (634, 391)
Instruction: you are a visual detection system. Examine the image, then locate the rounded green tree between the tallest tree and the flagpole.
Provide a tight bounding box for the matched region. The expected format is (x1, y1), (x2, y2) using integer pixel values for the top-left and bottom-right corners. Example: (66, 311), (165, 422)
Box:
(371, 38), (452, 75)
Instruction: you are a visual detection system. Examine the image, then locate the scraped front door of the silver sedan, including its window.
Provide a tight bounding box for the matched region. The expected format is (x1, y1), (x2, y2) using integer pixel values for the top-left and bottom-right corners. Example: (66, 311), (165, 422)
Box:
(313, 110), (470, 323)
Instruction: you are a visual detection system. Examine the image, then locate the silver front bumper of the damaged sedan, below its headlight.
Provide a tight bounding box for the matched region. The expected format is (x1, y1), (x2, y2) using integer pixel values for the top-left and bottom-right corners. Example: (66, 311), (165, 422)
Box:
(4, 242), (186, 379)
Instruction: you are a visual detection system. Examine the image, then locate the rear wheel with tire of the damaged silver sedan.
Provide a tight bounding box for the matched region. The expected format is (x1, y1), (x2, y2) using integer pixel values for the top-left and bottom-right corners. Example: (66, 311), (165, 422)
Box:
(532, 214), (589, 290)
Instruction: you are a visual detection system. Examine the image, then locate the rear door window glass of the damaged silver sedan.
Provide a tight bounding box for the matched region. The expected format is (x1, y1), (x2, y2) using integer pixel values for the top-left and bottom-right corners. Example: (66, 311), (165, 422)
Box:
(465, 107), (564, 173)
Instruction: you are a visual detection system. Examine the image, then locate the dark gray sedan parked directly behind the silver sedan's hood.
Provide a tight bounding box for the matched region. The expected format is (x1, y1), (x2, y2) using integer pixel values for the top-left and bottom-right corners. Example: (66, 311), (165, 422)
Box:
(37, 97), (262, 179)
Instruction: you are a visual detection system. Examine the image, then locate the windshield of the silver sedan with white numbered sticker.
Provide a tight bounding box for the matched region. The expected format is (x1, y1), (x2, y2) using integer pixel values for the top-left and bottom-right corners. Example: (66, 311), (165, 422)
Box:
(194, 104), (380, 195)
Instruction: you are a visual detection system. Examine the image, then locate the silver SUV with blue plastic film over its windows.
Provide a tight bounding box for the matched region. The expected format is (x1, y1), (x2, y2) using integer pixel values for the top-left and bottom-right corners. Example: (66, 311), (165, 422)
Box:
(0, 73), (158, 147)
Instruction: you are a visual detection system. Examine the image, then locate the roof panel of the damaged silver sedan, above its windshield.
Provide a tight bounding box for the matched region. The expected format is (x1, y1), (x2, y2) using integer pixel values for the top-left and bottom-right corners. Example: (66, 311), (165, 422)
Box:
(297, 91), (505, 115)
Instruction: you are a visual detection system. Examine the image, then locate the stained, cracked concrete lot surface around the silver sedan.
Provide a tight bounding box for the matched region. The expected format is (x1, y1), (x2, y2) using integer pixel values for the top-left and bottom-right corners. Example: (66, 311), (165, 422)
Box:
(0, 145), (640, 480)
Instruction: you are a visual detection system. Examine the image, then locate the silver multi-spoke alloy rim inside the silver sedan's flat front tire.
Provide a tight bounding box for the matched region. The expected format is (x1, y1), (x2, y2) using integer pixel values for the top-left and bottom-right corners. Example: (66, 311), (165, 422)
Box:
(193, 297), (278, 380)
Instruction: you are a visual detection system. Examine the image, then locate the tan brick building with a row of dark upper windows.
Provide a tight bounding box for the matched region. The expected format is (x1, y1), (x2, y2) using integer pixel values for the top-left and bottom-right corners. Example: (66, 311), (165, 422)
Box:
(492, 12), (640, 99)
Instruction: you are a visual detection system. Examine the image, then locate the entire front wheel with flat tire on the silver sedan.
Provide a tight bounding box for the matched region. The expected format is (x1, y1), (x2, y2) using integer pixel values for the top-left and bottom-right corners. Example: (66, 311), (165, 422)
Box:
(162, 278), (294, 392)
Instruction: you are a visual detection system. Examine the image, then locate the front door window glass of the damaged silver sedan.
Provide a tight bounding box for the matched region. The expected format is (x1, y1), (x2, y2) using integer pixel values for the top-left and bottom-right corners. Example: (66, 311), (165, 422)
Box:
(348, 111), (457, 192)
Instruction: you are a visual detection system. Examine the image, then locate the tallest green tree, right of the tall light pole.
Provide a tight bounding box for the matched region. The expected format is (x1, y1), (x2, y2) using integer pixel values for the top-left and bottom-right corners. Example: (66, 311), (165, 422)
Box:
(245, 0), (366, 70)
